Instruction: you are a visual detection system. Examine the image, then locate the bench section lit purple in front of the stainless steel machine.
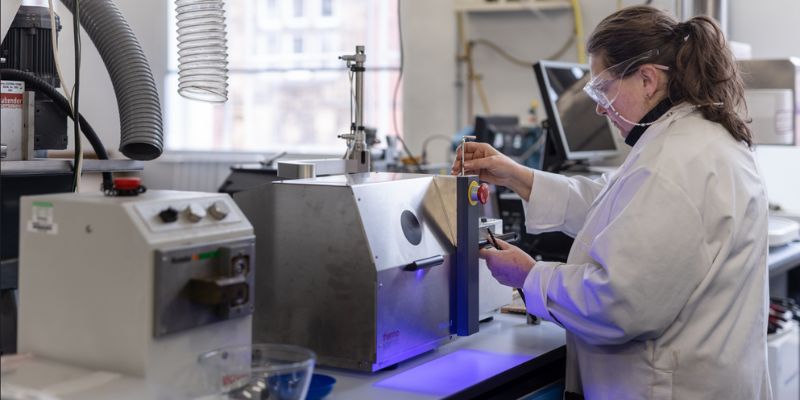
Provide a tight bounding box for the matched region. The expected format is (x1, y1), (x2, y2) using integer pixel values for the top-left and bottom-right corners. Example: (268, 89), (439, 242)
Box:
(316, 313), (566, 400)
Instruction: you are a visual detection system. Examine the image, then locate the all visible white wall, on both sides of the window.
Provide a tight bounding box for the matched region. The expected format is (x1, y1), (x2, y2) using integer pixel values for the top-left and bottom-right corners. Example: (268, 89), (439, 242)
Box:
(53, 0), (800, 209)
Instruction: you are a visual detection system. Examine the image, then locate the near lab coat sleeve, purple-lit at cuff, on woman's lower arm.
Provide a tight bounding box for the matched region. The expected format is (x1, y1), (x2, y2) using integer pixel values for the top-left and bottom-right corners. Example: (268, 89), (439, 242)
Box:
(524, 171), (711, 345)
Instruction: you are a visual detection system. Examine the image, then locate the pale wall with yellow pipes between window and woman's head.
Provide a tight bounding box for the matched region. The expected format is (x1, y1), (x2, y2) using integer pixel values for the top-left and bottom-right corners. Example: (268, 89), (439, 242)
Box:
(401, 0), (673, 166)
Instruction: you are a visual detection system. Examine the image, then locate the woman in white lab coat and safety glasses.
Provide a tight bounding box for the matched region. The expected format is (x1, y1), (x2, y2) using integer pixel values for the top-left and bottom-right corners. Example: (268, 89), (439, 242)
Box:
(453, 6), (771, 399)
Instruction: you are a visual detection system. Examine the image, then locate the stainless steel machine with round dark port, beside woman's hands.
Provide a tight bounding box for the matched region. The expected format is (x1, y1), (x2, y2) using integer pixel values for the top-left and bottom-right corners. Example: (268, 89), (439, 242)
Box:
(234, 172), (494, 371)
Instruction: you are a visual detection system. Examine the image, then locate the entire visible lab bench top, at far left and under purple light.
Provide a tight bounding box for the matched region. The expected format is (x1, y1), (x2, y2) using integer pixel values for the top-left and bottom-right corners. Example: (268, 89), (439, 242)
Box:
(2, 313), (566, 400)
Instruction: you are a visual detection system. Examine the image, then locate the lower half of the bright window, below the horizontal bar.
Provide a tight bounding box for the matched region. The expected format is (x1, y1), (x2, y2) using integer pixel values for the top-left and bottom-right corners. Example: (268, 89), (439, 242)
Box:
(166, 70), (402, 153)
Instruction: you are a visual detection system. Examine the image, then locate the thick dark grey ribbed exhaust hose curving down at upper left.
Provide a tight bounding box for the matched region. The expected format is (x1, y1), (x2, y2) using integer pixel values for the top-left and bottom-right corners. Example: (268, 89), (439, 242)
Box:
(61, 0), (164, 161)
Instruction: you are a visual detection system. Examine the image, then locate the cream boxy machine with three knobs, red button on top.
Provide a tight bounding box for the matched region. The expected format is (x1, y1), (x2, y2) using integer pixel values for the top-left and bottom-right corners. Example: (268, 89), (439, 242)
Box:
(19, 191), (256, 386)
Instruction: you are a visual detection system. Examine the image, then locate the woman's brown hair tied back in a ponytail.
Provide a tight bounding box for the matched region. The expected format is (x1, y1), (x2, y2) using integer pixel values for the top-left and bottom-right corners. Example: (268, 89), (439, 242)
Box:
(587, 6), (753, 146)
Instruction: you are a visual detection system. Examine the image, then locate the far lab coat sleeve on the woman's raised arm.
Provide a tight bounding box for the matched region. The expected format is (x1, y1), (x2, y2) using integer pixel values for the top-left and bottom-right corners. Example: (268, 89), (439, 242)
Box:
(523, 171), (607, 237)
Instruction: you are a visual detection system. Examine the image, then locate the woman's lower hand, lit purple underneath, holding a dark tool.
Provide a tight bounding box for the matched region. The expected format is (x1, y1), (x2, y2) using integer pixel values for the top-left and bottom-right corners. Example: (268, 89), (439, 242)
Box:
(478, 239), (536, 288)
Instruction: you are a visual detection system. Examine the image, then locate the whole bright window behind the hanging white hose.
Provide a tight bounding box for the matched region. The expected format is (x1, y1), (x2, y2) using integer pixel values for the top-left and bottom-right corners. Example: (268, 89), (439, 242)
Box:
(164, 0), (402, 154)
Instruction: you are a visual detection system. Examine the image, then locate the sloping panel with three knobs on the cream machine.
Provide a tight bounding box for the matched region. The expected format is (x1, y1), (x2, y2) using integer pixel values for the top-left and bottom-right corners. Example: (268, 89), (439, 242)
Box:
(135, 197), (242, 233)
